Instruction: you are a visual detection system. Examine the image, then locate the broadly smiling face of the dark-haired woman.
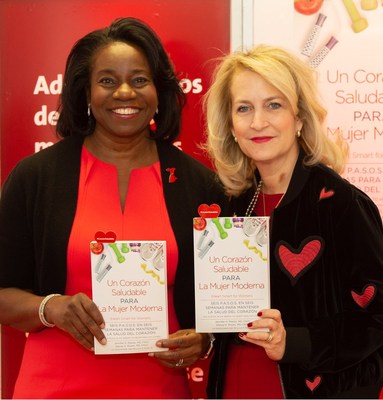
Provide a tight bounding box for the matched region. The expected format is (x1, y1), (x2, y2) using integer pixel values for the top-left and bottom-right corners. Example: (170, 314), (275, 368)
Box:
(89, 42), (158, 139)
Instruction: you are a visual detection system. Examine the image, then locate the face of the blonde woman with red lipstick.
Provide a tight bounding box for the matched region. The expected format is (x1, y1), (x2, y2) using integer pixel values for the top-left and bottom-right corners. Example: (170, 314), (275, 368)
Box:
(230, 69), (302, 172)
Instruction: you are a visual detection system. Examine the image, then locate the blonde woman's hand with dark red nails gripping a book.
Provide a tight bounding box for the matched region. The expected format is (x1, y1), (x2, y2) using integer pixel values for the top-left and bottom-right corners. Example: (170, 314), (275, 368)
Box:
(239, 309), (286, 361)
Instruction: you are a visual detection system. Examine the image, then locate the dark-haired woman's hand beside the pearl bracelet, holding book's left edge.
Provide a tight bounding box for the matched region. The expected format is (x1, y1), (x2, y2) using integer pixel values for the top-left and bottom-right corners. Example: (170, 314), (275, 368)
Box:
(44, 293), (106, 350)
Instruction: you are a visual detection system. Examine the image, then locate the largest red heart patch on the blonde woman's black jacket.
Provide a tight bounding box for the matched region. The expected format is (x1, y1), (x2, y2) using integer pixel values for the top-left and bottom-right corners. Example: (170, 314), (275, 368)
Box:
(277, 237), (323, 284)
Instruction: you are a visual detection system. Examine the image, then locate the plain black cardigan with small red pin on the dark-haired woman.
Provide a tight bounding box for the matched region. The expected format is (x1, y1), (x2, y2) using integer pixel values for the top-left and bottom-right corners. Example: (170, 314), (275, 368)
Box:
(0, 137), (230, 328)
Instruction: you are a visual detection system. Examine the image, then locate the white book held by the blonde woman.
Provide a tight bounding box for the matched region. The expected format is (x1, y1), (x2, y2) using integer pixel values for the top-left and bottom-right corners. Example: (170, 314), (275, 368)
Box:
(193, 217), (270, 333)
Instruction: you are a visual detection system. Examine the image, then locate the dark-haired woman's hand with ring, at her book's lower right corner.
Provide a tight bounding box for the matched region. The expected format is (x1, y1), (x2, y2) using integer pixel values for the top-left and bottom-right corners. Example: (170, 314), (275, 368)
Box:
(148, 329), (207, 368)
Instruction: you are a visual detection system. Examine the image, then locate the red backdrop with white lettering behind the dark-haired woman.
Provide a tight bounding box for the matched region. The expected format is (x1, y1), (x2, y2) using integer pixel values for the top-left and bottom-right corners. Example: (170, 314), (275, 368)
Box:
(0, 0), (230, 398)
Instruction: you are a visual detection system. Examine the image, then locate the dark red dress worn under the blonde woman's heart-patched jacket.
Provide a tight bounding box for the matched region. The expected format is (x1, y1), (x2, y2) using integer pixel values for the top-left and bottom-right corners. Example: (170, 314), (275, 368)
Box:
(223, 193), (284, 399)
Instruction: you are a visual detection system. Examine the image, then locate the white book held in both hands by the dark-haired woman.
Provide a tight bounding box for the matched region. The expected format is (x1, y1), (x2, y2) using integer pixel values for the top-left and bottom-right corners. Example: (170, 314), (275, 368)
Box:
(90, 241), (169, 354)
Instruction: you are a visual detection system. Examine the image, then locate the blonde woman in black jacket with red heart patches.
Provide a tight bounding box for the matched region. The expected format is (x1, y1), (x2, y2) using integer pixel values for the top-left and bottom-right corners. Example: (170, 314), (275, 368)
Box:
(205, 45), (383, 399)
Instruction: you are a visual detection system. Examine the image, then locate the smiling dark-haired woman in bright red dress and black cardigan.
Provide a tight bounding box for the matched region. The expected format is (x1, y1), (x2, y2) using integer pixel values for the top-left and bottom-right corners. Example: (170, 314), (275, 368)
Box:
(0, 18), (225, 398)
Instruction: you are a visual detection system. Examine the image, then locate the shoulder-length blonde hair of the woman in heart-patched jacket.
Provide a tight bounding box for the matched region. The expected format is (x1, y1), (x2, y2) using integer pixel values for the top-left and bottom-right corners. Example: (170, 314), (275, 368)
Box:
(203, 45), (348, 196)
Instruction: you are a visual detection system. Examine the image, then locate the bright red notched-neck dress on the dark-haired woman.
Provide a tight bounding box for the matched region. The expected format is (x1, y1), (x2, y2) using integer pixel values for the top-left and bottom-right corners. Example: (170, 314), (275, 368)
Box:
(14, 147), (191, 399)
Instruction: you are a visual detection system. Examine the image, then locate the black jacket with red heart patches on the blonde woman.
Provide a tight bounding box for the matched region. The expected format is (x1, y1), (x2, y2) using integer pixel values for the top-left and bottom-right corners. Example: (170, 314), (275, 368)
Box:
(208, 153), (383, 398)
